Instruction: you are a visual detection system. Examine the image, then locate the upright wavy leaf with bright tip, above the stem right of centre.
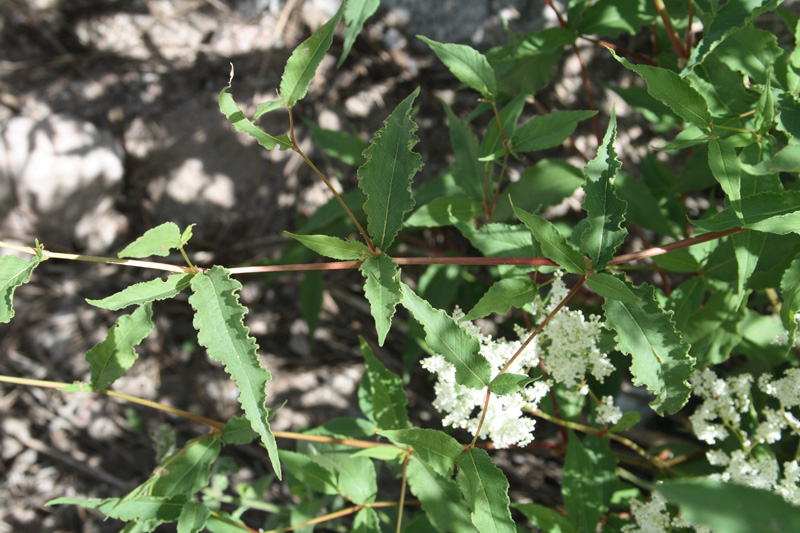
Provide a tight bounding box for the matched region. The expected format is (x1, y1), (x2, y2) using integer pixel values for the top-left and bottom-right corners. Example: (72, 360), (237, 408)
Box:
(581, 110), (628, 270)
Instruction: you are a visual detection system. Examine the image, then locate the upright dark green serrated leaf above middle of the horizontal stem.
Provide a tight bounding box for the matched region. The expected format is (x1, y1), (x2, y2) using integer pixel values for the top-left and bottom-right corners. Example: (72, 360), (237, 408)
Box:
(358, 87), (422, 251)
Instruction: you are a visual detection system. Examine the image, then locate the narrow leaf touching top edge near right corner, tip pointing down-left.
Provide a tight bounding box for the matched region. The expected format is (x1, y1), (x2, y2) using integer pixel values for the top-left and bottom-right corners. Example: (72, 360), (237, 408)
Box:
(685, 0), (780, 71)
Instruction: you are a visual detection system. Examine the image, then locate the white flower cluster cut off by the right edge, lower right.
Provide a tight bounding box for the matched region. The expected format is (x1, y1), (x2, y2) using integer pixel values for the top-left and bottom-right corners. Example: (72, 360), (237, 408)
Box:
(689, 368), (800, 506)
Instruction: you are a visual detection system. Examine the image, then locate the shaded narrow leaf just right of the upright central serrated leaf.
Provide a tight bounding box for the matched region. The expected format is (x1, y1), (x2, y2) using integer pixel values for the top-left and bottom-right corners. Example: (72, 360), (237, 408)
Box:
(441, 100), (486, 201)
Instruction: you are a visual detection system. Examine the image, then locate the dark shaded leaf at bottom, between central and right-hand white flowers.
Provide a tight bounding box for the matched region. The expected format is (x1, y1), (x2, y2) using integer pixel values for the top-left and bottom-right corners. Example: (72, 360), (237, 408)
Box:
(561, 431), (618, 533)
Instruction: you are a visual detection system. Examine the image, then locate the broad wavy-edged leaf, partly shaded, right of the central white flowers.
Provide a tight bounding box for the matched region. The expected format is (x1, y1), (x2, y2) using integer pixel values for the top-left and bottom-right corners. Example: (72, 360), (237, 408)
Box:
(603, 282), (694, 415)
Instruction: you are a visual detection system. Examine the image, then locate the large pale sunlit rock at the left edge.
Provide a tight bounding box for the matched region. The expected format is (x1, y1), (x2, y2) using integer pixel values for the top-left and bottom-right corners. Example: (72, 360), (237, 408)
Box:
(0, 114), (125, 253)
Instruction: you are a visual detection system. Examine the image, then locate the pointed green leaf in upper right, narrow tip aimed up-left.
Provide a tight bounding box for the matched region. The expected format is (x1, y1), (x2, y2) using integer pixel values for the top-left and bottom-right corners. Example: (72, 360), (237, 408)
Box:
(609, 50), (711, 130)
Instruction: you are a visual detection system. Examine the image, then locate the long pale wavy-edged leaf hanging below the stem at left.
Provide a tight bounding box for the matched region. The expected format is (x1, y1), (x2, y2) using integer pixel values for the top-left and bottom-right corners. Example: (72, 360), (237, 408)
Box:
(189, 266), (281, 478)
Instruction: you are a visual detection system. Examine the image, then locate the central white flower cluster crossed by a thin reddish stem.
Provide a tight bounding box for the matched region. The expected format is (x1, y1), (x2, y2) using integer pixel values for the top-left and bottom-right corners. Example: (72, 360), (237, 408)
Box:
(422, 273), (622, 448)
